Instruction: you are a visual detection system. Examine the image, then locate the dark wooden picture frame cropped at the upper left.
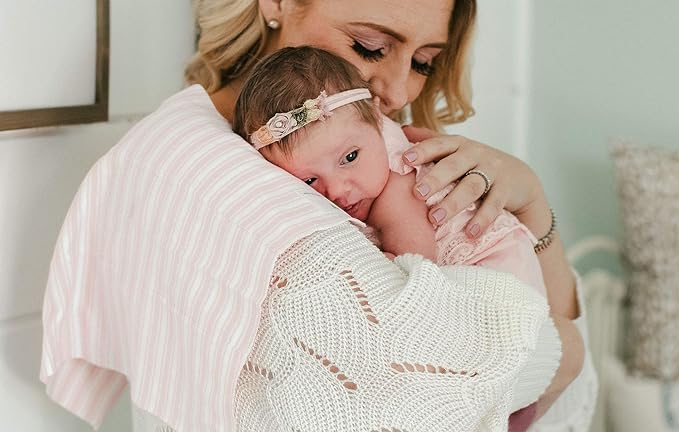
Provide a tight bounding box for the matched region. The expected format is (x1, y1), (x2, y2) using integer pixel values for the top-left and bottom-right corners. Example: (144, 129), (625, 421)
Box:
(0, 0), (109, 131)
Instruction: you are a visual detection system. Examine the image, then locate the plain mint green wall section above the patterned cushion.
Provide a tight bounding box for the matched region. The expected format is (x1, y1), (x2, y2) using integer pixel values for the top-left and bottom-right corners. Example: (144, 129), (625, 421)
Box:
(527, 0), (679, 274)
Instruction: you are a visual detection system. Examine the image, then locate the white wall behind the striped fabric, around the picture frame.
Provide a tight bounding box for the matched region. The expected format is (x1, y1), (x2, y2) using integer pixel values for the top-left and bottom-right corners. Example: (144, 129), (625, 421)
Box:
(0, 0), (193, 432)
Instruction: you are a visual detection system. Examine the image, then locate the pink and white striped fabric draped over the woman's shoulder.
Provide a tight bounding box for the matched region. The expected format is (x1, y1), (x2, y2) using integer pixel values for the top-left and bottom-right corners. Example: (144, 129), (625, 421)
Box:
(40, 85), (356, 431)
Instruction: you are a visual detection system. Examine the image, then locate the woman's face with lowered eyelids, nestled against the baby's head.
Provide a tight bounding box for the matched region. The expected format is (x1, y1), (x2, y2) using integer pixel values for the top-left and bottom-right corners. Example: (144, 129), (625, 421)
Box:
(275, 0), (453, 114)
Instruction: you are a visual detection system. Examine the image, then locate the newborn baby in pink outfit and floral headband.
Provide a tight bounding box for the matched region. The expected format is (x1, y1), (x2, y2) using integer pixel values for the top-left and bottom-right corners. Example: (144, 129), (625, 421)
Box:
(233, 47), (584, 416)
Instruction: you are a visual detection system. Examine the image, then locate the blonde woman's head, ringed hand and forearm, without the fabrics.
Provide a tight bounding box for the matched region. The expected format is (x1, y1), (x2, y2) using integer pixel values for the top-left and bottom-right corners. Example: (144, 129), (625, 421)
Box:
(191, 0), (578, 318)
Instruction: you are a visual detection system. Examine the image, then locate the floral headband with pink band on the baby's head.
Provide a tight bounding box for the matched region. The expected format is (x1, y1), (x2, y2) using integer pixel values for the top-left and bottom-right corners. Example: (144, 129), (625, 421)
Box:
(250, 88), (372, 150)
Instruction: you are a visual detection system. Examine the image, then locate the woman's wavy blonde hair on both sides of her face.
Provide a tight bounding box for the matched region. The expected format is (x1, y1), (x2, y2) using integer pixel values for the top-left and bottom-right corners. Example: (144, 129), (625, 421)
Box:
(185, 0), (476, 129)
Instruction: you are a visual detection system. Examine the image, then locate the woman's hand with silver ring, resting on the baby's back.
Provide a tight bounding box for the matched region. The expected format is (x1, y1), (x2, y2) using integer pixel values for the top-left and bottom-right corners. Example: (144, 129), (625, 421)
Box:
(403, 126), (549, 237)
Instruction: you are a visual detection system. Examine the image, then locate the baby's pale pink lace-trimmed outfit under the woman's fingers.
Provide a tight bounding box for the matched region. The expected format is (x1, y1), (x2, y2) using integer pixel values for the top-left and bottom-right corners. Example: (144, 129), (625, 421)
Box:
(382, 117), (546, 294)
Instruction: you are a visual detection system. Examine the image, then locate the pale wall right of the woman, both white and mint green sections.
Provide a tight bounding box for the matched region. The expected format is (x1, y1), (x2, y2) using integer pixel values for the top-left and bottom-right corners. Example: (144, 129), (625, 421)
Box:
(462, 0), (679, 271)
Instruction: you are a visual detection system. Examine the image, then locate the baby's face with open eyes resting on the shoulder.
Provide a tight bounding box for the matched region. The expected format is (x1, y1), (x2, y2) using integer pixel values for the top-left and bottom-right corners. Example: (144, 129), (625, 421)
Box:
(268, 107), (389, 221)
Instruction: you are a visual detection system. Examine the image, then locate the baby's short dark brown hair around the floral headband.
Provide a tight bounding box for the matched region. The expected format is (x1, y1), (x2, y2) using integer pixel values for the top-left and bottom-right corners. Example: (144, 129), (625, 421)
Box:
(233, 46), (382, 156)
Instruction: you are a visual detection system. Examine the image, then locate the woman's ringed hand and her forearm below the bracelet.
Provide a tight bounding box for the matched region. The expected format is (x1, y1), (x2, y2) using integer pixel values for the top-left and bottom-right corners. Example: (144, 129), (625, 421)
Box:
(403, 126), (580, 319)
